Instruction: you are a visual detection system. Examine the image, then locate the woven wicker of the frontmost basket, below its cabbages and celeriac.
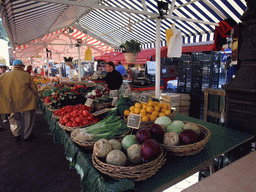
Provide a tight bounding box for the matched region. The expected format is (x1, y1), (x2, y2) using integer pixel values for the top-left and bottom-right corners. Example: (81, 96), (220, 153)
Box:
(92, 150), (166, 181)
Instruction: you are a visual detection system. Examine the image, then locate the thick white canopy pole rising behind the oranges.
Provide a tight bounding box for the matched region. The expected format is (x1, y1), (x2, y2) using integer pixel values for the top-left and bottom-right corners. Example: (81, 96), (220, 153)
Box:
(155, 18), (161, 99)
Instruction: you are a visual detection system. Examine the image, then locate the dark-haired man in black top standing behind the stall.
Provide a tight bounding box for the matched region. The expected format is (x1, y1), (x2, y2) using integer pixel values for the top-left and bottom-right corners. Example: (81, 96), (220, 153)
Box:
(105, 61), (123, 90)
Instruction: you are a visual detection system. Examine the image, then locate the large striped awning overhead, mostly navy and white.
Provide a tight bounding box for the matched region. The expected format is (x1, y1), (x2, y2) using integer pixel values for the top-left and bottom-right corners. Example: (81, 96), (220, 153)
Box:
(0, 0), (246, 58)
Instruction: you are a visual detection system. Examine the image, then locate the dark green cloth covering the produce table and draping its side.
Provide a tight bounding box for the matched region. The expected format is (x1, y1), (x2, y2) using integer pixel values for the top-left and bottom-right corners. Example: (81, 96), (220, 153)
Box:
(41, 104), (253, 192)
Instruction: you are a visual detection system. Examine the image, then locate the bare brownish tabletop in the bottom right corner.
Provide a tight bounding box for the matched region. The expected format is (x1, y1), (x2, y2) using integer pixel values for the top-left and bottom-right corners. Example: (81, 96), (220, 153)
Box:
(183, 151), (256, 192)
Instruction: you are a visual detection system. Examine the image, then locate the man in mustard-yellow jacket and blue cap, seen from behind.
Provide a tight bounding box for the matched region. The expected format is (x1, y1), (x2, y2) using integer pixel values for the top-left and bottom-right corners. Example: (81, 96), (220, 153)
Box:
(0, 60), (37, 141)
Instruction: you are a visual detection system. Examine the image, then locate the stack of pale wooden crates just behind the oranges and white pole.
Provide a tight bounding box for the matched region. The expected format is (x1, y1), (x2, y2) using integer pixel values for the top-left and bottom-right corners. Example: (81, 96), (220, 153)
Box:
(161, 93), (190, 116)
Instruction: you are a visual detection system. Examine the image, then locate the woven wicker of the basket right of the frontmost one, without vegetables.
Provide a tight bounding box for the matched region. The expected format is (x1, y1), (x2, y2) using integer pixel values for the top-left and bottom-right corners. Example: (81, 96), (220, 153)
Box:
(161, 122), (211, 156)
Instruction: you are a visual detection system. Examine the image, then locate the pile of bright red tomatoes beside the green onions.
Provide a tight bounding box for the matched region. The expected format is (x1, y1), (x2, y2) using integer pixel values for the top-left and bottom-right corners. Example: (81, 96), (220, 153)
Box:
(54, 104), (99, 127)
